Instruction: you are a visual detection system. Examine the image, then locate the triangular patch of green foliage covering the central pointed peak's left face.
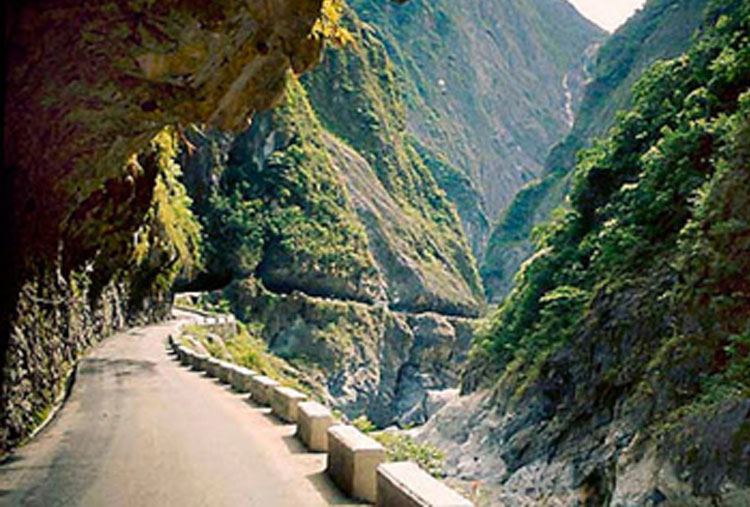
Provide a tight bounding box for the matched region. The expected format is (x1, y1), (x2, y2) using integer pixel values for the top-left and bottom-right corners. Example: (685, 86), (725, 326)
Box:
(195, 81), (374, 298)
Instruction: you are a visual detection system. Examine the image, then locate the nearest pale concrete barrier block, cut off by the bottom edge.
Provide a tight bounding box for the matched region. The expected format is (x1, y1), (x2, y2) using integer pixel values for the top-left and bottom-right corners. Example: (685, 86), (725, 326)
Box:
(377, 461), (474, 507)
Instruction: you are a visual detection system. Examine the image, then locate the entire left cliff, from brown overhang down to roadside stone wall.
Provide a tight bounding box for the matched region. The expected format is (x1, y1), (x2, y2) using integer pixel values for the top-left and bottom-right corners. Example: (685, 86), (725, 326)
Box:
(0, 0), (330, 449)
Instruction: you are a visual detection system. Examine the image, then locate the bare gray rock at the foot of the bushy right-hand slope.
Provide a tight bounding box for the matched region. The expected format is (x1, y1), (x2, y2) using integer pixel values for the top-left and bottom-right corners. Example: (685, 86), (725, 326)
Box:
(415, 368), (750, 507)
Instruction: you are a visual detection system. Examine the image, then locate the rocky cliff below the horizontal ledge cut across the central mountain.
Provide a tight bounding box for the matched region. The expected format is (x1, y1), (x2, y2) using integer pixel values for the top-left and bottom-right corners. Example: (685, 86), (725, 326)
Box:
(224, 280), (475, 427)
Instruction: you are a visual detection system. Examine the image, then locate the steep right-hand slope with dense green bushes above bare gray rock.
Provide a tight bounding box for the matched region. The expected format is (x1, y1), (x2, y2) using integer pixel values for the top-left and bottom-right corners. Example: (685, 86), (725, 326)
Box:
(423, 0), (750, 505)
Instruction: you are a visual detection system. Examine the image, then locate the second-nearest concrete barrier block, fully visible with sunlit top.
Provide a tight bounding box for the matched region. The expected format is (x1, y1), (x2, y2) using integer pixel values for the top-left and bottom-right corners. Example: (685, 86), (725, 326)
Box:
(326, 425), (385, 503)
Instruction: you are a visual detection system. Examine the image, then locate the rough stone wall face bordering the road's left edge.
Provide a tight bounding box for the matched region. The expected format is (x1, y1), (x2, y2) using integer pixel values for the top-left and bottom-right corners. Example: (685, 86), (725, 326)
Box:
(0, 264), (168, 451)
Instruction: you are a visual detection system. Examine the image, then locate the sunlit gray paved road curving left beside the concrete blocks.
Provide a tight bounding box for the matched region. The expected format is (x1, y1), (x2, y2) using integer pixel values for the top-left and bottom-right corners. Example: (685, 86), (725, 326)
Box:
(0, 314), (364, 507)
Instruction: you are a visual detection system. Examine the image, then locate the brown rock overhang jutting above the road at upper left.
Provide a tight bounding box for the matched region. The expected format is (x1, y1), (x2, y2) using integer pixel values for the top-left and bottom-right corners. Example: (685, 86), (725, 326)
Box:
(4, 0), (321, 278)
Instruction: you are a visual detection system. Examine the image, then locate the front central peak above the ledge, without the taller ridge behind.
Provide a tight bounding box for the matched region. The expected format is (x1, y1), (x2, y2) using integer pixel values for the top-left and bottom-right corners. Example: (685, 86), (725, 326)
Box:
(183, 77), (482, 316)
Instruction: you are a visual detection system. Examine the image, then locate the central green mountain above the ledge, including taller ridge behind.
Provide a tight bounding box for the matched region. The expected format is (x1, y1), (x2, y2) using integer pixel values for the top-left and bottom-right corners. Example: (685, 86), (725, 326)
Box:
(185, 10), (483, 315)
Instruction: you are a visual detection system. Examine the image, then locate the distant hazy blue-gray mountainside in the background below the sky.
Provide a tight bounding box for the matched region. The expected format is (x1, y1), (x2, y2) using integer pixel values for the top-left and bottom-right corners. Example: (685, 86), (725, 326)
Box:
(350, 0), (603, 255)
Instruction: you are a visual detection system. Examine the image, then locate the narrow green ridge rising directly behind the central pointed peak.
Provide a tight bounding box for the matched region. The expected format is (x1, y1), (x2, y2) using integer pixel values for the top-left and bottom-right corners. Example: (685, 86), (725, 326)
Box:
(303, 14), (460, 235)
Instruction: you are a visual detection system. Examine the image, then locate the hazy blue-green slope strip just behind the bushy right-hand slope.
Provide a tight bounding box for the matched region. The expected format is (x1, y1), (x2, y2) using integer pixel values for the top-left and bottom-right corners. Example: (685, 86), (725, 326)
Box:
(480, 0), (708, 302)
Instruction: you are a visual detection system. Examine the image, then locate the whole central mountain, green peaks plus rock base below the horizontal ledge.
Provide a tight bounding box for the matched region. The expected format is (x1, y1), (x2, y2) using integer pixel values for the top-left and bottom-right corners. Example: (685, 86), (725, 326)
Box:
(183, 12), (483, 426)
